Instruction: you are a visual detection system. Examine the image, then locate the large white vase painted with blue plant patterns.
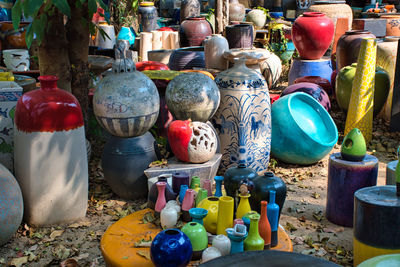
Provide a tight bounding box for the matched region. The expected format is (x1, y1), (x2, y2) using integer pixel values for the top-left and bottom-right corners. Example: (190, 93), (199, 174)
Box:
(212, 58), (271, 172)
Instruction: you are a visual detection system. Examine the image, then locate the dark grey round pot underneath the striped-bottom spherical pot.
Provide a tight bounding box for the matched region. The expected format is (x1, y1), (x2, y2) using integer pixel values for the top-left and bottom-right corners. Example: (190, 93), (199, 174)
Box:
(101, 132), (157, 200)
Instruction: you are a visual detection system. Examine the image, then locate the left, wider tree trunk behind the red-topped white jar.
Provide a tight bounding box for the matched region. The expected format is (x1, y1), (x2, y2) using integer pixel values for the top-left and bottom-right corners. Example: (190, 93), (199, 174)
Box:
(38, 9), (71, 92)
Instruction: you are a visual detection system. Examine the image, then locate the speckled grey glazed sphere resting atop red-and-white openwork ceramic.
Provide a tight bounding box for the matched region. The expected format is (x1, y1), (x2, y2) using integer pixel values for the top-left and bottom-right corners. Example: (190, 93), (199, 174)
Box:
(165, 72), (220, 122)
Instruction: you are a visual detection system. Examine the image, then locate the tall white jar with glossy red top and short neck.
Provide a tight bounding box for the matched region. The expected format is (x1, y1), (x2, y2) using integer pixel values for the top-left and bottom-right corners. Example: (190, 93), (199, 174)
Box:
(14, 76), (88, 226)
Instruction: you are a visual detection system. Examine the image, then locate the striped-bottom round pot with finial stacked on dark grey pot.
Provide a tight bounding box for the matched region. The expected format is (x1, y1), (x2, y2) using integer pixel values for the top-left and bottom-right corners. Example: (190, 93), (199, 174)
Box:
(93, 40), (160, 199)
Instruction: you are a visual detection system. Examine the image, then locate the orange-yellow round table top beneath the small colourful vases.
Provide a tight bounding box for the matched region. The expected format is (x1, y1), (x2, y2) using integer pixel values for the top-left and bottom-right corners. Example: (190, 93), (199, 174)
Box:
(100, 209), (293, 267)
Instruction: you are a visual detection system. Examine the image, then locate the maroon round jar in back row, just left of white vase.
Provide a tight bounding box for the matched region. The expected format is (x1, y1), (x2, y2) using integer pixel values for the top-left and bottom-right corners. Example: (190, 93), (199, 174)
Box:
(179, 17), (212, 47)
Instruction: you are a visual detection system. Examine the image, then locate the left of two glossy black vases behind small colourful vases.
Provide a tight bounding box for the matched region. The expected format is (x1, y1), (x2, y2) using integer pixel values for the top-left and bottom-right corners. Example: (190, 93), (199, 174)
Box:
(224, 163), (257, 198)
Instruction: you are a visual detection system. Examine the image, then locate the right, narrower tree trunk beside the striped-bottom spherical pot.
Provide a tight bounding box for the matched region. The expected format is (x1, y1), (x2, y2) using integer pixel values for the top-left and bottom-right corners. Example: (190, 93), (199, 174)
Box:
(66, 0), (91, 129)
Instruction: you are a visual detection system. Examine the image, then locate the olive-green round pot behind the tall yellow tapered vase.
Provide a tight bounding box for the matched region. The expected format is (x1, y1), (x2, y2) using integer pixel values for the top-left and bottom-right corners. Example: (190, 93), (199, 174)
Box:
(335, 63), (390, 116)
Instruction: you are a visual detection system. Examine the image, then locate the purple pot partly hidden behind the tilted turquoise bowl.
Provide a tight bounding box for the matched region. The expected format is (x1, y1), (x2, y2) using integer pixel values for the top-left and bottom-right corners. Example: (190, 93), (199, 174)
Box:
(281, 82), (331, 112)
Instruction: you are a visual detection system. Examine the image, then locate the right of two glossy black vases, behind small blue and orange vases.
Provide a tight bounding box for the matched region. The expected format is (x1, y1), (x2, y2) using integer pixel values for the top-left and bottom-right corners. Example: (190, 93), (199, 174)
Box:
(249, 172), (286, 218)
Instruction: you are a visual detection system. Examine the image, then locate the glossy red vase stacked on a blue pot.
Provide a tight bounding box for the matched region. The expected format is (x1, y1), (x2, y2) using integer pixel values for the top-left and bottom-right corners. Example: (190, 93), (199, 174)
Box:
(289, 12), (334, 85)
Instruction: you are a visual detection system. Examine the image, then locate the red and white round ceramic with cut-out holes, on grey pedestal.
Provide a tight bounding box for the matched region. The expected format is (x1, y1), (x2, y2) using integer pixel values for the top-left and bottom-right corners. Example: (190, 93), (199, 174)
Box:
(167, 120), (217, 163)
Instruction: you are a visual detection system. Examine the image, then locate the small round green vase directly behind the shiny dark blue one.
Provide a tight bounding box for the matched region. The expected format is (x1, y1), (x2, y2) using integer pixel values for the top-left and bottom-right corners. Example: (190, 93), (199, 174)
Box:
(181, 222), (208, 260)
